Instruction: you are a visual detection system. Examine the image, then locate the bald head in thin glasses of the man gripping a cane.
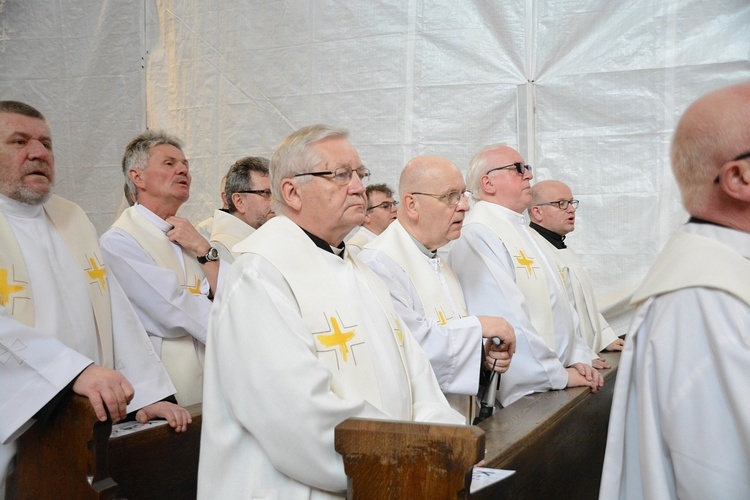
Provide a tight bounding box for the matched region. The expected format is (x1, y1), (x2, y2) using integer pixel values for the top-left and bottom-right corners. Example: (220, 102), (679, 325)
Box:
(398, 156), (469, 251)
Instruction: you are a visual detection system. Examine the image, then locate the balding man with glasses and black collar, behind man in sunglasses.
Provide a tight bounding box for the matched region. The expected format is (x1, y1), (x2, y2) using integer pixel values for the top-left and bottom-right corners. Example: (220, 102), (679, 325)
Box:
(528, 180), (623, 352)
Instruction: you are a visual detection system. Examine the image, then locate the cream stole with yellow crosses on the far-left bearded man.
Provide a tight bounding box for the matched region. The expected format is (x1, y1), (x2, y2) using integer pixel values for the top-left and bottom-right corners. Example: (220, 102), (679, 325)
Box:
(0, 195), (114, 369)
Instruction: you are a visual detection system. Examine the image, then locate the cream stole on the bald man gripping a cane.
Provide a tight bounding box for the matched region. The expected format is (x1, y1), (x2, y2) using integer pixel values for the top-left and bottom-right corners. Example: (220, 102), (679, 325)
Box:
(366, 220), (474, 422)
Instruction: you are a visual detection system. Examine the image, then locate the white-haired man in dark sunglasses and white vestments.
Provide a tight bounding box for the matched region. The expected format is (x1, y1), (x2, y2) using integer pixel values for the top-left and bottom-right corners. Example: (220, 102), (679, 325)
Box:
(450, 146), (604, 406)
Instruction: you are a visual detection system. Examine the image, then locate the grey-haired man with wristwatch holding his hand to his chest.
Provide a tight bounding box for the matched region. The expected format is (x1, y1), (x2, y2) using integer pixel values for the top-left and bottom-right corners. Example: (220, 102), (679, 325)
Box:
(100, 131), (228, 405)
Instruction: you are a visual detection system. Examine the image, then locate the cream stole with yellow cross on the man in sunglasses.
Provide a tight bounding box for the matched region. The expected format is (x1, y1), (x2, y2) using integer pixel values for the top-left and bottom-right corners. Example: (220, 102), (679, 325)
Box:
(464, 201), (557, 351)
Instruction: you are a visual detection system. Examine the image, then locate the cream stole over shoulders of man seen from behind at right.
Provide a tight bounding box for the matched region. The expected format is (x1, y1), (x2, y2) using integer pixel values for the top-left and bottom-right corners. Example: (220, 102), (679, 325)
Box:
(630, 232), (750, 305)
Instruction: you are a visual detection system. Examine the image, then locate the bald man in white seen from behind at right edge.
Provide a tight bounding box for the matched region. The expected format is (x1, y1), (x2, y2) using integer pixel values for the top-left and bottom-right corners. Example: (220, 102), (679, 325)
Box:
(600, 83), (750, 500)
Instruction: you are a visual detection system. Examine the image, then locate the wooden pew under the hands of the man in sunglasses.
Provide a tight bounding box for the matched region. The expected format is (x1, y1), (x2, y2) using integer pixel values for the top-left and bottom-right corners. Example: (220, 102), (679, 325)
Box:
(476, 353), (620, 500)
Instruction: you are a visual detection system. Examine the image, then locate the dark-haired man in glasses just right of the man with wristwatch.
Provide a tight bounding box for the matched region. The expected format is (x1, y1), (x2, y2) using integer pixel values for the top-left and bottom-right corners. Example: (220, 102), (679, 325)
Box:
(209, 156), (276, 263)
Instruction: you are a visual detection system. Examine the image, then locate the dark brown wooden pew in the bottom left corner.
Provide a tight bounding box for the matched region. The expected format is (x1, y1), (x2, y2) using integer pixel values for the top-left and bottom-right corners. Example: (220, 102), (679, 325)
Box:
(6, 395), (201, 500)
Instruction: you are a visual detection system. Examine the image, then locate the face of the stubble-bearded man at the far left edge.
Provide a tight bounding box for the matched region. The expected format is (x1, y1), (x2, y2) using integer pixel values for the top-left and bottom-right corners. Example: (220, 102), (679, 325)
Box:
(0, 113), (55, 205)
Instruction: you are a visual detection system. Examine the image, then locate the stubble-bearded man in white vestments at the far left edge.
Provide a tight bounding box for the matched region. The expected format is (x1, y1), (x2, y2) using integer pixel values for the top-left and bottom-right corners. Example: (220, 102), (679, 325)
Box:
(0, 101), (190, 498)
